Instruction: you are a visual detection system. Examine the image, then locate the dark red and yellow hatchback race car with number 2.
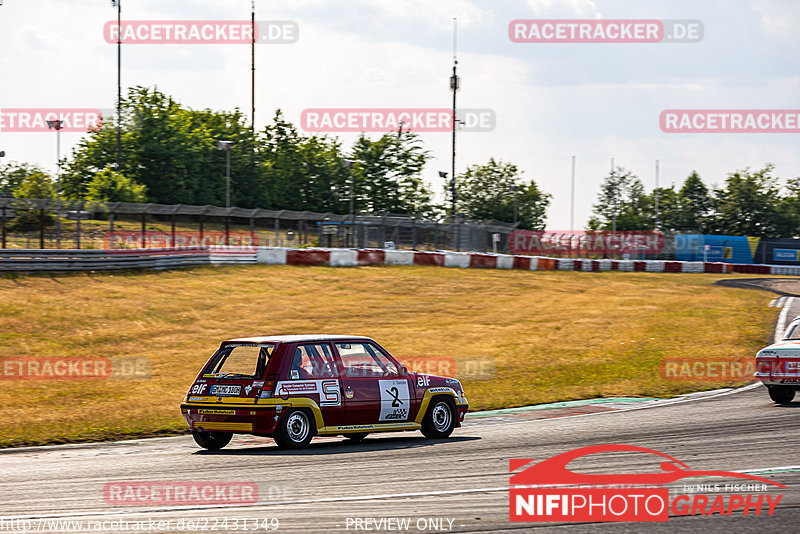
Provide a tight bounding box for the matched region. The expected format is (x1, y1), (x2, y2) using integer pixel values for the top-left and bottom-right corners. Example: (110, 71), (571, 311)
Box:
(181, 335), (469, 450)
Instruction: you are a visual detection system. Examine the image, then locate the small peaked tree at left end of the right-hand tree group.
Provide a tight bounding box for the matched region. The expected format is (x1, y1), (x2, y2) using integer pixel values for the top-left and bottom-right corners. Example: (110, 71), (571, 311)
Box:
(589, 167), (655, 230)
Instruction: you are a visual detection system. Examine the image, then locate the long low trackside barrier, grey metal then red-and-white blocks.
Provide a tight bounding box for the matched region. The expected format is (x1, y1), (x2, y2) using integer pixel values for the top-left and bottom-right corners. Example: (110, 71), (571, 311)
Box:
(0, 246), (800, 276)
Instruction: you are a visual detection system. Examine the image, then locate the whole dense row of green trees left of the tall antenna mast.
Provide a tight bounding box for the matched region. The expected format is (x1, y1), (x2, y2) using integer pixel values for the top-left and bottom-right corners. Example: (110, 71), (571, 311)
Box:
(57, 87), (444, 215)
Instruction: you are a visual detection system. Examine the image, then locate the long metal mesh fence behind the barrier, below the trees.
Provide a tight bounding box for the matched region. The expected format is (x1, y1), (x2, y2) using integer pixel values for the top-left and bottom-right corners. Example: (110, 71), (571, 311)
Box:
(0, 197), (515, 253)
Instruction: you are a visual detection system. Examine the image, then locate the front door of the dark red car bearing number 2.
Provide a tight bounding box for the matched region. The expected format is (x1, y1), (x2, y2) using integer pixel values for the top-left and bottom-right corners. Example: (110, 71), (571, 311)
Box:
(333, 341), (412, 425)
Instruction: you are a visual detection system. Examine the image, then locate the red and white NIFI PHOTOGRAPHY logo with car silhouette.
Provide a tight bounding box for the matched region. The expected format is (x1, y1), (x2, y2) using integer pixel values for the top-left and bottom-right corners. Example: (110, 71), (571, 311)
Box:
(509, 444), (786, 522)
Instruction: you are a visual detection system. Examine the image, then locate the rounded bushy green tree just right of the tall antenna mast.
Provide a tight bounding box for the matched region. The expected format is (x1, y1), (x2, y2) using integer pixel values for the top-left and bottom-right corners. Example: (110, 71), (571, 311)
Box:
(457, 158), (552, 230)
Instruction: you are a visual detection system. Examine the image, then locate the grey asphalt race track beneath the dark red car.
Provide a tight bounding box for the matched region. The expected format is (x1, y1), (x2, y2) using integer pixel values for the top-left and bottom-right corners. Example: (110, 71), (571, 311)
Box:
(0, 282), (800, 533)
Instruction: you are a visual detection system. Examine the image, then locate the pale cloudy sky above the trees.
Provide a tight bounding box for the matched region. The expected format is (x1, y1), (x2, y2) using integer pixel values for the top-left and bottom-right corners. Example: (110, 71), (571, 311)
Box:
(0, 0), (800, 230)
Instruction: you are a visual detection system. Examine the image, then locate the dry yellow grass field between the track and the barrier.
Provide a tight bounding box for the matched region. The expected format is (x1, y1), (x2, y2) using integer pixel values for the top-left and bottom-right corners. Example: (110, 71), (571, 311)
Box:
(0, 266), (776, 446)
